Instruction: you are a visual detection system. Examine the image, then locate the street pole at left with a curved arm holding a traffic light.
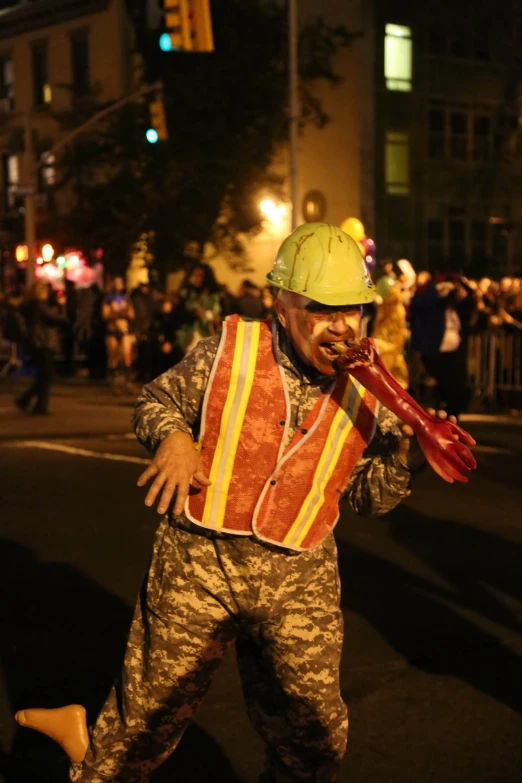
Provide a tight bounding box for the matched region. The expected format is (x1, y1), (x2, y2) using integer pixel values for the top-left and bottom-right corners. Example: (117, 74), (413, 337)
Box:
(24, 82), (163, 287)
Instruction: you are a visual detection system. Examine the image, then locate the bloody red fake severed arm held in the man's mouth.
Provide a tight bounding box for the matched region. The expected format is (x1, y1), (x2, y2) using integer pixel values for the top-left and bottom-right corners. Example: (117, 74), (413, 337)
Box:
(333, 338), (477, 483)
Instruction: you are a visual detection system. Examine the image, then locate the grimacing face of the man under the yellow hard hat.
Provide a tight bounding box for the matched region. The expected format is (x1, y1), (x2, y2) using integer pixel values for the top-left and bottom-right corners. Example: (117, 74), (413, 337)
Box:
(275, 291), (361, 375)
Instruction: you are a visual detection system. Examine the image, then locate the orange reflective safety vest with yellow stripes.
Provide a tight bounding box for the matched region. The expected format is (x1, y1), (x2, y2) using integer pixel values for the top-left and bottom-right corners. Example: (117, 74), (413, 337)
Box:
(185, 316), (377, 550)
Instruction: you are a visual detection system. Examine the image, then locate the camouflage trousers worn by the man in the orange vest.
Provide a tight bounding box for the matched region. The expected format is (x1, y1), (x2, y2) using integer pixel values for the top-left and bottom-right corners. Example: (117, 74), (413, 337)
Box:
(71, 520), (348, 783)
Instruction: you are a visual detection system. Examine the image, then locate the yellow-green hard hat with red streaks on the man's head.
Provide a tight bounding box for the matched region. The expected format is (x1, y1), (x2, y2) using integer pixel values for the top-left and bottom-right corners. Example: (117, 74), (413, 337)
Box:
(266, 223), (375, 305)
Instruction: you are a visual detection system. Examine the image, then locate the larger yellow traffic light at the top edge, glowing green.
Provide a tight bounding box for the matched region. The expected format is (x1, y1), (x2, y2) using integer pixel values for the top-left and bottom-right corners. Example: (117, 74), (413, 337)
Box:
(159, 0), (214, 52)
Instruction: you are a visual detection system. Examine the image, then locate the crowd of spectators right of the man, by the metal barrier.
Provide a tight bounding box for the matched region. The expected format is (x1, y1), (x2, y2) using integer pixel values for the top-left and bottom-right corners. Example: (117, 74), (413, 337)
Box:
(368, 266), (522, 416)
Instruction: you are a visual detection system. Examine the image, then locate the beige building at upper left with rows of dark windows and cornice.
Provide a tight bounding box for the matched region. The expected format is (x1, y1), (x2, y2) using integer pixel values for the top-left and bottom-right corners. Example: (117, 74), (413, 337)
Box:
(0, 0), (133, 276)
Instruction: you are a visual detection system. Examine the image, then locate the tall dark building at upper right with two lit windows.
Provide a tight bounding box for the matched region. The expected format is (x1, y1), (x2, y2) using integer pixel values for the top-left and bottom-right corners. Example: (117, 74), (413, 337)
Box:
(292, 0), (522, 276)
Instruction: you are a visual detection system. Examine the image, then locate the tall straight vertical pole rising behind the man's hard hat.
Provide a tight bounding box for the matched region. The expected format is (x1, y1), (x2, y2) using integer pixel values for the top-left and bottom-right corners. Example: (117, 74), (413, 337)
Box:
(288, 0), (299, 231)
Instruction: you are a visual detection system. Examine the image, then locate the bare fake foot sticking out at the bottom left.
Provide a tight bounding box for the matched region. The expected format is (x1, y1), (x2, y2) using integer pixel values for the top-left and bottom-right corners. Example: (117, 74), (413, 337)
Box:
(15, 704), (89, 763)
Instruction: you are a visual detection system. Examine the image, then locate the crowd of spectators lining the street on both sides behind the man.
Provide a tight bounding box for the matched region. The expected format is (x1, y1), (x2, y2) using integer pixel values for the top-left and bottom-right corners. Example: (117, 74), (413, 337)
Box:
(0, 243), (522, 415)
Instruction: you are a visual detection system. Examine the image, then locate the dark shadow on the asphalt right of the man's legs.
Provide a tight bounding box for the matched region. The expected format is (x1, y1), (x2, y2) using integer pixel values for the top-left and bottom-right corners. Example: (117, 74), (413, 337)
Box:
(338, 506), (522, 713)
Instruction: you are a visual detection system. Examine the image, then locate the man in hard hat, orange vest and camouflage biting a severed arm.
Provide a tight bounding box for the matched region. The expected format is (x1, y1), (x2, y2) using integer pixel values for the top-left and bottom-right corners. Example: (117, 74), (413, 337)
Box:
(14, 223), (474, 783)
